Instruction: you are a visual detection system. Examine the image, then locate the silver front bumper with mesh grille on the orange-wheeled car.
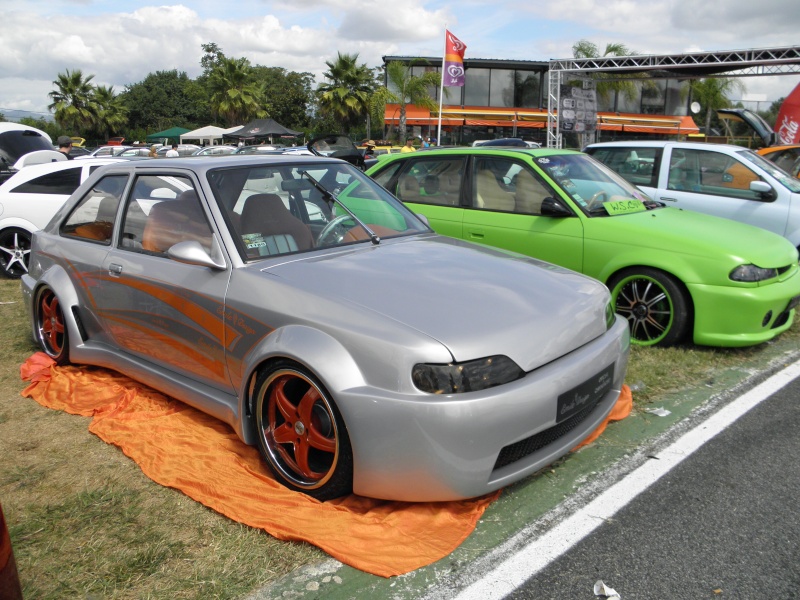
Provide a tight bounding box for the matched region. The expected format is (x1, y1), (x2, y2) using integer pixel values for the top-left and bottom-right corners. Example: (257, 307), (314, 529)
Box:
(344, 317), (630, 501)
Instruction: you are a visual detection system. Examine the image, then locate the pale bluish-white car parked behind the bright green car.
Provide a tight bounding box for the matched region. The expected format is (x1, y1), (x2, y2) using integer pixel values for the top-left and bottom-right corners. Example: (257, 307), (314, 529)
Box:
(585, 141), (800, 248)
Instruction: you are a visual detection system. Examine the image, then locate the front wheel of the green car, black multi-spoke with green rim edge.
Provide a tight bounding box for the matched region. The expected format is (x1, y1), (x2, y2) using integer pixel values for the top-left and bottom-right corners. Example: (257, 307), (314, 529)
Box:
(608, 267), (691, 346)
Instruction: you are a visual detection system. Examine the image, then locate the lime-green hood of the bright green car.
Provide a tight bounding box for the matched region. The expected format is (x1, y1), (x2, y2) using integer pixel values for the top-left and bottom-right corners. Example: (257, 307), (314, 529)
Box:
(584, 207), (797, 268)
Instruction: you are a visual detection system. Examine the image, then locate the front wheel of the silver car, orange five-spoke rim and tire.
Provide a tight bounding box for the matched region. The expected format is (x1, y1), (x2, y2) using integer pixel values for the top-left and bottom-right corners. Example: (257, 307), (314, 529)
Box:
(255, 361), (353, 500)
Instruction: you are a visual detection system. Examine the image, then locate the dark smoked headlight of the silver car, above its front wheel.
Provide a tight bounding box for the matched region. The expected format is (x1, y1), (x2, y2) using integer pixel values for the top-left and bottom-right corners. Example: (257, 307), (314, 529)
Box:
(411, 356), (525, 394)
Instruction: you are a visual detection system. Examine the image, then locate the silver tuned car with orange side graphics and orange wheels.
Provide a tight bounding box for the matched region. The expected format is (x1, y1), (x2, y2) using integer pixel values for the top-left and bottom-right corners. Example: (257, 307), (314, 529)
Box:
(22, 156), (629, 501)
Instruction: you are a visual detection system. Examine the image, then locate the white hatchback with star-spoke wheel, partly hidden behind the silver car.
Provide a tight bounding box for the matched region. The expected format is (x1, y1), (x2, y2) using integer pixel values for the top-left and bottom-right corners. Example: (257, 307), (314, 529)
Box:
(0, 158), (120, 278)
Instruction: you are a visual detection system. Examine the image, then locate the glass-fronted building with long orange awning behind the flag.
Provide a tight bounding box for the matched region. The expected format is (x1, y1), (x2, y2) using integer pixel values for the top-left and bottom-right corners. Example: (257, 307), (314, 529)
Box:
(383, 56), (698, 145)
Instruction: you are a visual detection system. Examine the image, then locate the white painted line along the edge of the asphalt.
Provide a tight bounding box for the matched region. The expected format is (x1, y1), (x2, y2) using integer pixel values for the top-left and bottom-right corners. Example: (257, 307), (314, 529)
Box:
(455, 361), (800, 600)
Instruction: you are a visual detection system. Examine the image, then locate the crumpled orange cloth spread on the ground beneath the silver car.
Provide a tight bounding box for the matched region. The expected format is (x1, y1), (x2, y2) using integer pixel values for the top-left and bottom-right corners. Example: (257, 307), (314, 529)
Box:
(20, 352), (630, 577)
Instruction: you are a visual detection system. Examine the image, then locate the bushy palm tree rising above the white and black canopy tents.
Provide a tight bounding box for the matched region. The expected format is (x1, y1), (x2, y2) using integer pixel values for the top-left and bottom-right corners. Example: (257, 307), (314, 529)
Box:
(208, 57), (268, 126)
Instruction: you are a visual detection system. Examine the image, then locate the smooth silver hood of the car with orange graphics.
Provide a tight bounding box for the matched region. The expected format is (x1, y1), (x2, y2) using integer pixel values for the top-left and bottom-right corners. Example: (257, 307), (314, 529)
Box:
(263, 235), (609, 371)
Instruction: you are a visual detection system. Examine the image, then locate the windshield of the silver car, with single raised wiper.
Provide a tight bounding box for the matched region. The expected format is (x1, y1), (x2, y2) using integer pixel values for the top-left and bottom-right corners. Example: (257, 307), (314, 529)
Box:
(208, 160), (430, 261)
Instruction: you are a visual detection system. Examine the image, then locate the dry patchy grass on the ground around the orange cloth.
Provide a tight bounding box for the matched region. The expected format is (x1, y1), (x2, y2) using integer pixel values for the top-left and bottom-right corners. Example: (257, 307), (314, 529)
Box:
(0, 280), (800, 600)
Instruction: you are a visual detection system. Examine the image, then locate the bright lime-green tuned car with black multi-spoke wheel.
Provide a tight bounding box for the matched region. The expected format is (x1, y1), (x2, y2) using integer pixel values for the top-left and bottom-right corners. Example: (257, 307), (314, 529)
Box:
(367, 148), (800, 346)
